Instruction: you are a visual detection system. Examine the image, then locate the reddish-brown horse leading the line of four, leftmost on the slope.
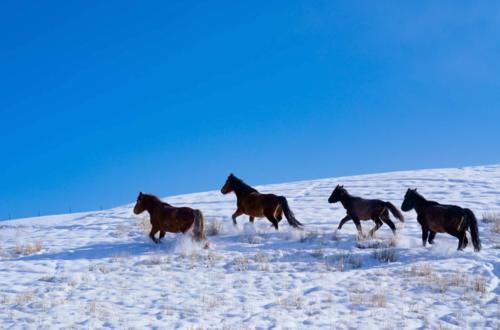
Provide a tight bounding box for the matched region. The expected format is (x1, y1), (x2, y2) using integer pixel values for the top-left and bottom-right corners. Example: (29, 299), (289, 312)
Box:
(134, 192), (205, 244)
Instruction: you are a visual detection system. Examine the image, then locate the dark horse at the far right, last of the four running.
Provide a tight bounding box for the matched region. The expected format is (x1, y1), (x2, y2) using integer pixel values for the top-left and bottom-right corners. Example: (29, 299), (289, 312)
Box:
(401, 189), (481, 252)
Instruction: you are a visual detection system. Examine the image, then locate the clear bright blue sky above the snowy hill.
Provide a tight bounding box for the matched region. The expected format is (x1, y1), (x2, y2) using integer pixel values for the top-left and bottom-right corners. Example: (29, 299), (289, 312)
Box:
(0, 0), (500, 219)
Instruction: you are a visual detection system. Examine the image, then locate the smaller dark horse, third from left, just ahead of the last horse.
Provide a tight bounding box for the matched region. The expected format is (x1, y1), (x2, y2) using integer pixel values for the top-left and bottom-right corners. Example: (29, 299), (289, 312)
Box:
(328, 185), (404, 237)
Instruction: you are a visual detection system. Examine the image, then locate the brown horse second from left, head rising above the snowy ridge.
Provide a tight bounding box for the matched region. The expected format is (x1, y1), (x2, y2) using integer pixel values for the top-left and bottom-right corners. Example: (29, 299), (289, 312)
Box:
(220, 174), (303, 230)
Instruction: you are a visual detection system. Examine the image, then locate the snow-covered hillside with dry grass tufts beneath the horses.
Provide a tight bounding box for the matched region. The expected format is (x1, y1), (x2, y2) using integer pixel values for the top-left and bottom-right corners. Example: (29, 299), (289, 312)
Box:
(0, 165), (500, 329)
